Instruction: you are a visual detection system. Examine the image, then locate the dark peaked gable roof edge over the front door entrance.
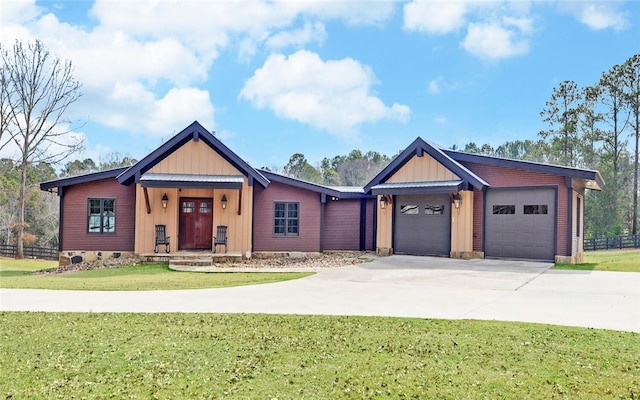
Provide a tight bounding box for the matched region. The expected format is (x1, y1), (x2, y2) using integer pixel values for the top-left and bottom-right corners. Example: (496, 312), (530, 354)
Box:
(118, 121), (269, 187)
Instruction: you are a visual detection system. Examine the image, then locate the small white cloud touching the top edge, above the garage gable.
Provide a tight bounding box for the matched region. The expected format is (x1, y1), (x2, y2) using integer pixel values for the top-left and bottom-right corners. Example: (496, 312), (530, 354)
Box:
(404, 0), (467, 34)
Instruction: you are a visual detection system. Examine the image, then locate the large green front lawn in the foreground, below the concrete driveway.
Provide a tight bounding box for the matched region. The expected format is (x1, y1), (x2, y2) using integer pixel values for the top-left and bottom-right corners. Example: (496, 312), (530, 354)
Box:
(0, 312), (640, 399)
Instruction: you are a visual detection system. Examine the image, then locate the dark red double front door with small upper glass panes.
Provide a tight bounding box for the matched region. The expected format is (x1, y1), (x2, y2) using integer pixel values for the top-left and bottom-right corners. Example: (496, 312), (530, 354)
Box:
(178, 197), (213, 250)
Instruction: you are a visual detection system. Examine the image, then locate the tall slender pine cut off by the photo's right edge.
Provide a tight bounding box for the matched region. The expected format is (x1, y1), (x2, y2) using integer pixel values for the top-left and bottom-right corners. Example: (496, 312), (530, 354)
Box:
(622, 54), (640, 235)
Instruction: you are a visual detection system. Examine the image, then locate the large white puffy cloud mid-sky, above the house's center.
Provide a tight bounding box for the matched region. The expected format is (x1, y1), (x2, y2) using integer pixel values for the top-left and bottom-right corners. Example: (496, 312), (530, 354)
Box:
(240, 50), (410, 137)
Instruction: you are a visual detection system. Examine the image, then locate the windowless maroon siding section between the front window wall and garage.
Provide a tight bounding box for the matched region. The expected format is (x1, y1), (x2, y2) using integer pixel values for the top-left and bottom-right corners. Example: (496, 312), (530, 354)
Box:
(324, 199), (361, 250)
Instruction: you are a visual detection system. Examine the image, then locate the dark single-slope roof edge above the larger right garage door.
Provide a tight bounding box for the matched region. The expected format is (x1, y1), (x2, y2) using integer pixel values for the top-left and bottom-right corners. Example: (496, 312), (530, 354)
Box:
(443, 150), (604, 190)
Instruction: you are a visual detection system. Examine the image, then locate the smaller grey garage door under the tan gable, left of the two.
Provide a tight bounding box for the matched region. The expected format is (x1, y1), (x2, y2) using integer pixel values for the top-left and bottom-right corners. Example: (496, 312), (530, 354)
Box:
(393, 195), (451, 256)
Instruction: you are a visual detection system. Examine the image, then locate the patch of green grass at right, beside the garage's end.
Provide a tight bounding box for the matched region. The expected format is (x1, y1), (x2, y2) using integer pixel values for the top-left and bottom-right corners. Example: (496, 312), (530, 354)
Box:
(555, 250), (640, 272)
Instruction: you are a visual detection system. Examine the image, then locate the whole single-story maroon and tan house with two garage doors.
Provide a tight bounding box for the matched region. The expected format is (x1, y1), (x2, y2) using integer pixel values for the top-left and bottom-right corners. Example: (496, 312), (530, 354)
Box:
(40, 122), (603, 262)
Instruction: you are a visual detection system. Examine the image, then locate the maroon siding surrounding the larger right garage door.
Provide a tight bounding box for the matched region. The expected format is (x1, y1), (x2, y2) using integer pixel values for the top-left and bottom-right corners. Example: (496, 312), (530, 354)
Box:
(462, 162), (571, 255)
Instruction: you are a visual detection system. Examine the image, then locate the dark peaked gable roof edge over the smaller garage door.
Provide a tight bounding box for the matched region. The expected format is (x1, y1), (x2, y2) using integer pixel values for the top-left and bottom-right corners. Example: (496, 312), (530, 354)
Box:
(364, 137), (489, 193)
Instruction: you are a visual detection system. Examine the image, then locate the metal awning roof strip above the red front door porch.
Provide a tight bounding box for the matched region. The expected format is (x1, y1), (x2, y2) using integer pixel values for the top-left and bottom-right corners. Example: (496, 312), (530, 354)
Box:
(140, 173), (244, 189)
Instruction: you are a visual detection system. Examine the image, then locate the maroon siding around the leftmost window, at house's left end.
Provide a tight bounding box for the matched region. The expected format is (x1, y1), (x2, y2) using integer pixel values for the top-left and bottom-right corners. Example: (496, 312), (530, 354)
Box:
(60, 178), (136, 251)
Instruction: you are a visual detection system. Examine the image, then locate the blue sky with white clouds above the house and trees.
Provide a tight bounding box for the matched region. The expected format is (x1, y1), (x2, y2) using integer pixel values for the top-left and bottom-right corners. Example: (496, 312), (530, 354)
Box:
(0, 0), (640, 168)
